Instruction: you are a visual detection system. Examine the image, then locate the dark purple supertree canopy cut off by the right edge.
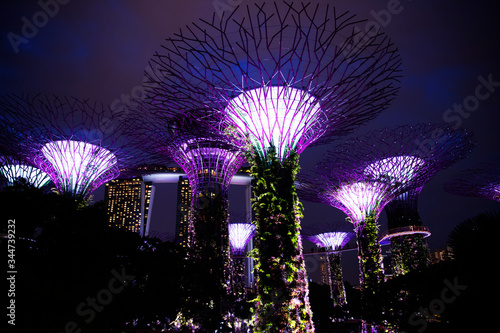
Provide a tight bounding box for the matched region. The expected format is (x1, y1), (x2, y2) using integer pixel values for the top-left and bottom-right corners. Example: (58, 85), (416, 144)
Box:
(444, 157), (500, 201)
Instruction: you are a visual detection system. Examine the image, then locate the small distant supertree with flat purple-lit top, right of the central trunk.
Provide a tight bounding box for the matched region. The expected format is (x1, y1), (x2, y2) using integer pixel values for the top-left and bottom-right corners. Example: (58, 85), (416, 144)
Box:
(305, 222), (355, 306)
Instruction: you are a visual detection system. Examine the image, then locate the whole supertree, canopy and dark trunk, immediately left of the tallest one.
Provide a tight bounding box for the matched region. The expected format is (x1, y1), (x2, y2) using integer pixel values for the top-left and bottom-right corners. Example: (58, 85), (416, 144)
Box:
(131, 111), (245, 331)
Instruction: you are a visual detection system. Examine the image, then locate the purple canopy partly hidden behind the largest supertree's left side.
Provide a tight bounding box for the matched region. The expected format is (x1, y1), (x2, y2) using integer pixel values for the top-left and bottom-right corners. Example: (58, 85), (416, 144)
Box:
(134, 111), (246, 196)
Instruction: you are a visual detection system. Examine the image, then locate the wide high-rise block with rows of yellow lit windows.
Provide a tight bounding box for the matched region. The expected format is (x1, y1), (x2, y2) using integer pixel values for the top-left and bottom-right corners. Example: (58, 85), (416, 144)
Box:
(105, 178), (152, 234)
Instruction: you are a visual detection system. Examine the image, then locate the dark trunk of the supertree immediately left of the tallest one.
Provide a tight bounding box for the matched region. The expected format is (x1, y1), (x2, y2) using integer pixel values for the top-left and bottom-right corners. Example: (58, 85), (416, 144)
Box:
(182, 183), (232, 332)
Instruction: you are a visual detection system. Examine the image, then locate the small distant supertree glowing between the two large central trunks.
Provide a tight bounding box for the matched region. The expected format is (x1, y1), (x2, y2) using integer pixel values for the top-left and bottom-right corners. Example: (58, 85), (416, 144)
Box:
(229, 223), (255, 297)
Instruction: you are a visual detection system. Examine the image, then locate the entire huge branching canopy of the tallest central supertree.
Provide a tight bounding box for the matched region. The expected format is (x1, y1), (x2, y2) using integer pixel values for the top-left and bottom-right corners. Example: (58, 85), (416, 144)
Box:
(146, 2), (400, 160)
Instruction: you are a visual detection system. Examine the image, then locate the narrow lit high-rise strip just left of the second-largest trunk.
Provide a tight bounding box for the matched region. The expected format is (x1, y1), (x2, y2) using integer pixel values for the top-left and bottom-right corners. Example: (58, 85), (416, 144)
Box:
(175, 176), (191, 247)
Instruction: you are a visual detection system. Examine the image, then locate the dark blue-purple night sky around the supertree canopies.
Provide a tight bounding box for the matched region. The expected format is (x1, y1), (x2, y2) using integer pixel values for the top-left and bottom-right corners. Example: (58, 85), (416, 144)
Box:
(0, 0), (500, 284)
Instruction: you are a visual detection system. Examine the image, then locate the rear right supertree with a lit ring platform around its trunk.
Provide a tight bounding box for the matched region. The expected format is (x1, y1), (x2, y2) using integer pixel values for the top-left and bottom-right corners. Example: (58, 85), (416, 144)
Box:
(358, 124), (475, 275)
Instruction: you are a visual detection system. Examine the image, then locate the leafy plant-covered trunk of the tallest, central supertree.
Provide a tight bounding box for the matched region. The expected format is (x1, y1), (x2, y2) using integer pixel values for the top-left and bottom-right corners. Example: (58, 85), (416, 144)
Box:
(252, 154), (314, 332)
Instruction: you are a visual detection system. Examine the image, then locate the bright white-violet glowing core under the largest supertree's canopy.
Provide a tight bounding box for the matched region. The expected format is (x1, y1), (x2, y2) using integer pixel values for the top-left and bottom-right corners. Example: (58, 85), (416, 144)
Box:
(225, 86), (322, 160)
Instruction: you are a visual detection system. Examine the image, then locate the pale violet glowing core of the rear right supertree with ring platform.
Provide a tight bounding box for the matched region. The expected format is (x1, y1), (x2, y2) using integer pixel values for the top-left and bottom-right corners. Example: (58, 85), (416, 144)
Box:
(365, 155), (425, 184)
